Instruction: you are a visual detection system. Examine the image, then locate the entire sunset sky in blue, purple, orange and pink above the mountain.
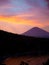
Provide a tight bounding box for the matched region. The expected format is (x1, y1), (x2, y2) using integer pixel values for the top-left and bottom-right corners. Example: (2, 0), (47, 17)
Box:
(0, 0), (49, 34)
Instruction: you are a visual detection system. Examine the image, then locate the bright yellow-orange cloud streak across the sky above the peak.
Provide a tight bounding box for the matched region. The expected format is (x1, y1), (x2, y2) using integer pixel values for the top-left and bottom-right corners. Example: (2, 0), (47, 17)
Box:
(0, 16), (42, 26)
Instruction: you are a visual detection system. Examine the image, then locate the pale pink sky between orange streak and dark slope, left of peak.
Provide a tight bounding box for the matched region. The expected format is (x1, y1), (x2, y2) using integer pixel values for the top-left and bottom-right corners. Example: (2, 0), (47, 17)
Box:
(0, 21), (32, 34)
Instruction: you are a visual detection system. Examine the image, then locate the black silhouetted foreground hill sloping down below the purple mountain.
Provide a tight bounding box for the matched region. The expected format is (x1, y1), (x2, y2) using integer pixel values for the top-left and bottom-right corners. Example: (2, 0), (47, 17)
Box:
(0, 30), (49, 56)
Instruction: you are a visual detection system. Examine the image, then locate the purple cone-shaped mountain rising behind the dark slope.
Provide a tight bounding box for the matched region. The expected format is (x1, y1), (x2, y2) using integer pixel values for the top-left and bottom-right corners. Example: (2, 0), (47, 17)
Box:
(22, 27), (49, 38)
